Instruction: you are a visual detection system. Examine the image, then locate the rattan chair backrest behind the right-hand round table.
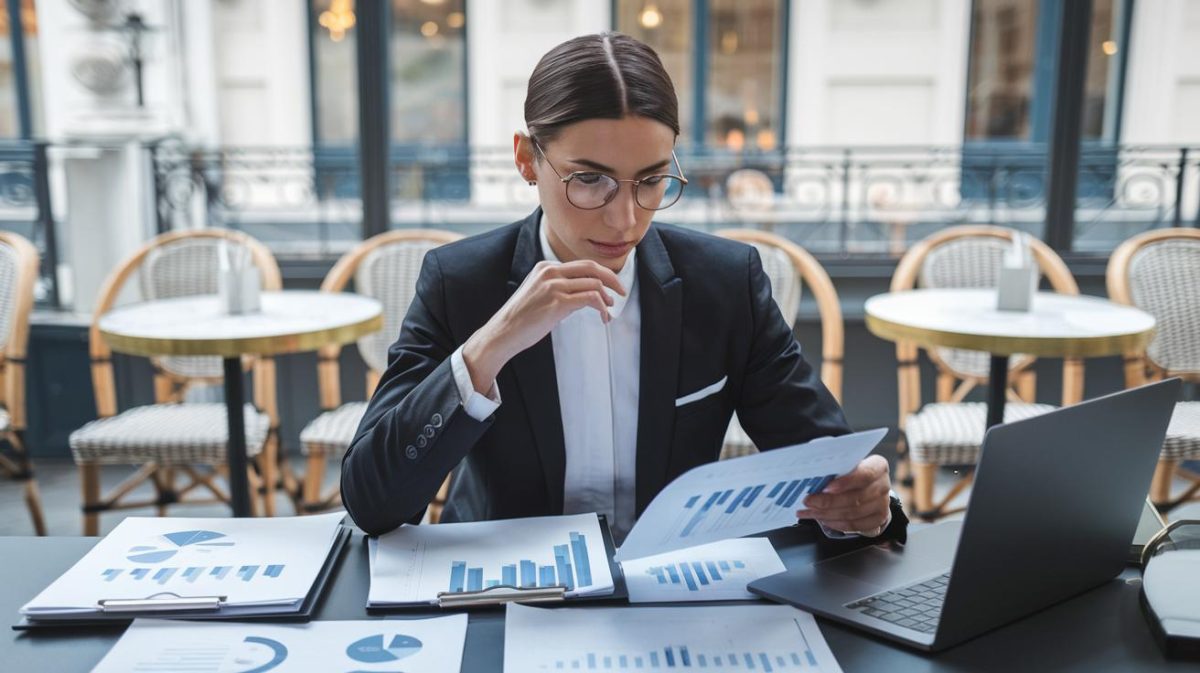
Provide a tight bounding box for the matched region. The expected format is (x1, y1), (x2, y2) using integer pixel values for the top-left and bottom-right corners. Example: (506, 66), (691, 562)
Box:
(890, 224), (1082, 423)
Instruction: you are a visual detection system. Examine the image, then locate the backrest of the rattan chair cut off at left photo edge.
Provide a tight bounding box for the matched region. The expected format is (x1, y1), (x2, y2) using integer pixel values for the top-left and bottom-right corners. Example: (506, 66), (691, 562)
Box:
(0, 232), (38, 431)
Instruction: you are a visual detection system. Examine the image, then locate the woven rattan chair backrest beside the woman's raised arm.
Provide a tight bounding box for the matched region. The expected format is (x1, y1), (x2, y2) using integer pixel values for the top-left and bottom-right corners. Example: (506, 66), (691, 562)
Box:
(319, 229), (462, 409)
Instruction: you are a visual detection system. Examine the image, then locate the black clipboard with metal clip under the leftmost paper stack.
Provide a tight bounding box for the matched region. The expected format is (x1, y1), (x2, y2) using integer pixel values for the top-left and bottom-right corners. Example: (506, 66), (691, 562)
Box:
(12, 525), (350, 631)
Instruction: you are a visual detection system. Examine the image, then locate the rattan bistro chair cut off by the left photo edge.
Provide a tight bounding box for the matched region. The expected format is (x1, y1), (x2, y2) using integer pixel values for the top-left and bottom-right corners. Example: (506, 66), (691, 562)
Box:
(0, 232), (46, 535)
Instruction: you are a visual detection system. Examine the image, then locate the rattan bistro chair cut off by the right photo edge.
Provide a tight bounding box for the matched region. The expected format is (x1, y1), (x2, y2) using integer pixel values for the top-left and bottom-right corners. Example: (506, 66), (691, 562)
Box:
(1108, 229), (1200, 511)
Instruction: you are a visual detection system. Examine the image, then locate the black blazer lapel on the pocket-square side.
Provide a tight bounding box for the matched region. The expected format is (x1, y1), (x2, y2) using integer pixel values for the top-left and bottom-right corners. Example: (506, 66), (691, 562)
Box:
(633, 226), (683, 516)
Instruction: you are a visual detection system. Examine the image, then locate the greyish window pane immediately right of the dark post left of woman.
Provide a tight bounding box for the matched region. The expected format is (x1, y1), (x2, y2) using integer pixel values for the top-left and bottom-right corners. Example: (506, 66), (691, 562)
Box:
(391, 0), (467, 144)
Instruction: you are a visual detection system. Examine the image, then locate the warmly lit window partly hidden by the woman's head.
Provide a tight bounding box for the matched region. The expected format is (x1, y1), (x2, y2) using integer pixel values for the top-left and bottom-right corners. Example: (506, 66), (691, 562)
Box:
(617, 0), (787, 151)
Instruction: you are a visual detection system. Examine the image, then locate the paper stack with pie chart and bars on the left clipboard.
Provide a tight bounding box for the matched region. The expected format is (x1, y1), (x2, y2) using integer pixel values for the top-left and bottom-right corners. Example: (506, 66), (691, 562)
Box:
(20, 512), (344, 620)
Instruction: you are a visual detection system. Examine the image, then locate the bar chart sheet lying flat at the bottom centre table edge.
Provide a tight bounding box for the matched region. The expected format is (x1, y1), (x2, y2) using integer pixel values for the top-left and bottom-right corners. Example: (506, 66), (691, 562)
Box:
(504, 605), (840, 673)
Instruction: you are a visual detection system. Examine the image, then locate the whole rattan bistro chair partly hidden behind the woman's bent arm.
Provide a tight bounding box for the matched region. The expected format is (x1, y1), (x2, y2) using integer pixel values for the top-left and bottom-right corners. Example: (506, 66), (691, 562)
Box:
(300, 229), (462, 515)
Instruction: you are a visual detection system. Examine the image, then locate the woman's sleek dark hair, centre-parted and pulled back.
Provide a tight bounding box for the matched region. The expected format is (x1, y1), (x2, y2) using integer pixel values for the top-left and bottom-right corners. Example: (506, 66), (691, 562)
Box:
(524, 32), (679, 146)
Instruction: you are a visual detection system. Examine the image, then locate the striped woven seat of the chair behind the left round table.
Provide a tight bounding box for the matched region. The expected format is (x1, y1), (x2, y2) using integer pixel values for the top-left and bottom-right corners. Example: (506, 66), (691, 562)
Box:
(70, 403), (271, 465)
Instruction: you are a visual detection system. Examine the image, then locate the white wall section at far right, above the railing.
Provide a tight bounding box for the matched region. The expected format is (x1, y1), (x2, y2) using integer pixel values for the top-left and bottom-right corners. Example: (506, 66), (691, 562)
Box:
(1121, 0), (1200, 144)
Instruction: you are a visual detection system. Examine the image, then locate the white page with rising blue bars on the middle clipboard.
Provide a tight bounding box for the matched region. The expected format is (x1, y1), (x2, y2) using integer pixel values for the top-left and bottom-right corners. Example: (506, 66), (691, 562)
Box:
(367, 513), (614, 607)
